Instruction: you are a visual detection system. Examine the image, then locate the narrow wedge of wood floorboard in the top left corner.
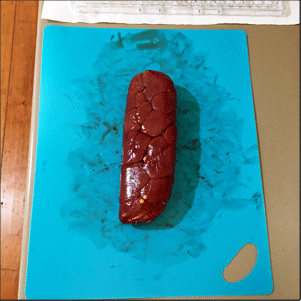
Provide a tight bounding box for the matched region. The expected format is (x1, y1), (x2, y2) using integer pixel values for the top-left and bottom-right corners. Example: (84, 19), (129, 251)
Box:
(1, 1), (16, 160)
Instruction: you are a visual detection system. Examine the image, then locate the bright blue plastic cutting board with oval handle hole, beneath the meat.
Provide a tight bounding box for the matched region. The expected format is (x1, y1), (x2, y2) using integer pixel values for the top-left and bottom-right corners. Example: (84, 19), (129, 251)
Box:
(25, 25), (273, 299)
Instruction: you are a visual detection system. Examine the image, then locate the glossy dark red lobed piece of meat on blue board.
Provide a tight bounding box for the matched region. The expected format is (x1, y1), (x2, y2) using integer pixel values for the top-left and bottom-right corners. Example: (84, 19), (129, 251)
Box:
(119, 70), (177, 224)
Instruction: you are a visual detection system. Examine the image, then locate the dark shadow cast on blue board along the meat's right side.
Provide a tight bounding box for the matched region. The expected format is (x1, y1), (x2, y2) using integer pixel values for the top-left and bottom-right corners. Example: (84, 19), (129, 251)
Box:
(133, 86), (201, 230)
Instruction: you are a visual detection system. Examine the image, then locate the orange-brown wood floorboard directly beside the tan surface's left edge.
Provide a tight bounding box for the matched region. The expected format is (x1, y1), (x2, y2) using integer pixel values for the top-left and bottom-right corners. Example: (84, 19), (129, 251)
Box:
(1, 1), (38, 299)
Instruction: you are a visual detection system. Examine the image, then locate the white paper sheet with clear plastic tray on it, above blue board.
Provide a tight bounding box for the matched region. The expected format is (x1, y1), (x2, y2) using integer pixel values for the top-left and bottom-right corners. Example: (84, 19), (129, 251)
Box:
(42, 1), (300, 25)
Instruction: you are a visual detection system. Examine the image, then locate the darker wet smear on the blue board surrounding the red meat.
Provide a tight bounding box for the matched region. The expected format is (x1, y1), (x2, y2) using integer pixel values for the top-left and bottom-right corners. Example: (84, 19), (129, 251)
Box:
(61, 30), (259, 264)
